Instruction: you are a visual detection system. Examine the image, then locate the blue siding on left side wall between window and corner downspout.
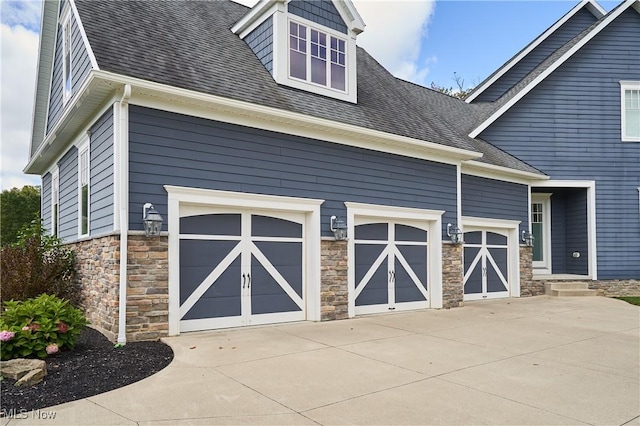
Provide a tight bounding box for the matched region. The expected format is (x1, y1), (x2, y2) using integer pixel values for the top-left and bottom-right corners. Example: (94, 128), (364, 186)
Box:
(89, 108), (114, 235)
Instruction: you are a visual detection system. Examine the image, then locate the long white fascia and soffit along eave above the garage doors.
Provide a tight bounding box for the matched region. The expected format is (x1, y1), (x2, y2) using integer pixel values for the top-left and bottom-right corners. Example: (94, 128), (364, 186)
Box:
(93, 71), (482, 165)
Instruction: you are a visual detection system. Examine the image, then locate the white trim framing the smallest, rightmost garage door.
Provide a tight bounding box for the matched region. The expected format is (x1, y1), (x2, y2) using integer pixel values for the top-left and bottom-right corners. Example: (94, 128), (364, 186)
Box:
(462, 216), (522, 300)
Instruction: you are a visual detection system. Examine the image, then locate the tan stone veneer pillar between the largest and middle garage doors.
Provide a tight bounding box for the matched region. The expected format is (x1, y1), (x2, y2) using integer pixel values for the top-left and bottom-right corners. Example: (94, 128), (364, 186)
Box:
(320, 240), (349, 321)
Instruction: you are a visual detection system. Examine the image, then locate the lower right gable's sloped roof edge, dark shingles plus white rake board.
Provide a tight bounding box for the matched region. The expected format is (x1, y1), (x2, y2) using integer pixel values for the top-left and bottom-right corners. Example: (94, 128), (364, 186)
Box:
(469, 0), (640, 138)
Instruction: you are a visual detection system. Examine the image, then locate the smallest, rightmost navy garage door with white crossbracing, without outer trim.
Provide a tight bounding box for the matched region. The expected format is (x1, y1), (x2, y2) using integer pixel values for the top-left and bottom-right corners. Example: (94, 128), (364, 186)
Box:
(464, 229), (509, 300)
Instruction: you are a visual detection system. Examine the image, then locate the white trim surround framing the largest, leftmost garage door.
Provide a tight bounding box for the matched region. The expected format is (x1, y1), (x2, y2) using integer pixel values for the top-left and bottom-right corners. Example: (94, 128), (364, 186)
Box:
(164, 185), (324, 336)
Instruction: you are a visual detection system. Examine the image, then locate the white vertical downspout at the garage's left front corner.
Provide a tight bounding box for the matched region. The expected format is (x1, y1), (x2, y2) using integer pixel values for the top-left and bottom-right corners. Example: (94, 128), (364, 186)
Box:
(117, 84), (131, 345)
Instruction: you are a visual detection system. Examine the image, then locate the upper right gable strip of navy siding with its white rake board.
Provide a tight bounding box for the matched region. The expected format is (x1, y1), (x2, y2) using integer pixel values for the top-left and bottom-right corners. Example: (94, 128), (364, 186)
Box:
(465, 0), (605, 103)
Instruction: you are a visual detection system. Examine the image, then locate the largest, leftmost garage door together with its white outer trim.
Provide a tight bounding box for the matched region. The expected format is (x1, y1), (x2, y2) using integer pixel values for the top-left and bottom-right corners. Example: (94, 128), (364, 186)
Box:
(165, 186), (322, 335)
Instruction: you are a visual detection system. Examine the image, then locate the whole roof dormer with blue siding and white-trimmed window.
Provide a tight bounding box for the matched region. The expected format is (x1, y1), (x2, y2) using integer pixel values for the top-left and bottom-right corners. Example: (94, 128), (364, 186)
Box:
(231, 0), (365, 103)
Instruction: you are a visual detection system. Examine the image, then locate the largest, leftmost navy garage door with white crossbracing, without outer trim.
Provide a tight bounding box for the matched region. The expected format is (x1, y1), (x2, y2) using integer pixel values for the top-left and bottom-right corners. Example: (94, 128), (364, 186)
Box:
(179, 211), (305, 331)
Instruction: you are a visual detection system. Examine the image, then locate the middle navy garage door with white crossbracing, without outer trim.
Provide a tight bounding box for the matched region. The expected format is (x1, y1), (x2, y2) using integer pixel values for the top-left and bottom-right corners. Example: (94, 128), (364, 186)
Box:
(354, 221), (429, 315)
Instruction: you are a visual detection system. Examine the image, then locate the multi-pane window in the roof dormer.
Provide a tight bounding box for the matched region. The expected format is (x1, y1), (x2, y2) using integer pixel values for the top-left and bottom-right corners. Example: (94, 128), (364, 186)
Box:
(289, 20), (347, 92)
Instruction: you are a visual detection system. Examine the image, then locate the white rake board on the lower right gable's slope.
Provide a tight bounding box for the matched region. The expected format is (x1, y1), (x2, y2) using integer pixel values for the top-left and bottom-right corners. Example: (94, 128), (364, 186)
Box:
(469, 0), (638, 138)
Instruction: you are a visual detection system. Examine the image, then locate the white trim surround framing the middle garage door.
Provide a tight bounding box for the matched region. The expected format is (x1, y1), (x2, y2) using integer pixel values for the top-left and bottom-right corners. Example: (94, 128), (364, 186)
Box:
(344, 202), (444, 317)
